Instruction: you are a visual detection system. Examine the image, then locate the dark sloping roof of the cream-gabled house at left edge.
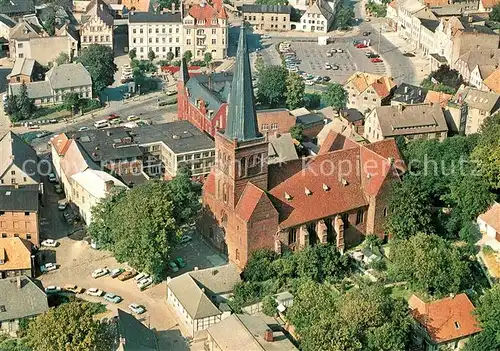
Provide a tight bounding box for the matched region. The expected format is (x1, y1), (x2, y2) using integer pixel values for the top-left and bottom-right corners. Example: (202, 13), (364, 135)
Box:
(0, 131), (40, 182)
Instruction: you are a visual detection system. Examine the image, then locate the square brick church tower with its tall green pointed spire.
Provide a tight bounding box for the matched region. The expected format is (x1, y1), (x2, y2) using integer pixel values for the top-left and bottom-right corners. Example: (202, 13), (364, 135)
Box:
(215, 23), (268, 210)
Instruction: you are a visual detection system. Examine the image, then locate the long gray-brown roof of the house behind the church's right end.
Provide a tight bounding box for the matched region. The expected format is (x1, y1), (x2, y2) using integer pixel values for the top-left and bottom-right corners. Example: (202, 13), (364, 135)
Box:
(374, 104), (448, 137)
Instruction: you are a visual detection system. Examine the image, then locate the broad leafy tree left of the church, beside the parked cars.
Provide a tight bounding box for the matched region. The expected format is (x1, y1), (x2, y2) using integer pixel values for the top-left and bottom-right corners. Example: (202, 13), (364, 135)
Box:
(89, 180), (199, 279)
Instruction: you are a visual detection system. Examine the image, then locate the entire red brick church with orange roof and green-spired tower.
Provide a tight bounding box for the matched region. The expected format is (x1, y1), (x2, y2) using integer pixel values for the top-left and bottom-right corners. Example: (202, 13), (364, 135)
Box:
(199, 28), (404, 268)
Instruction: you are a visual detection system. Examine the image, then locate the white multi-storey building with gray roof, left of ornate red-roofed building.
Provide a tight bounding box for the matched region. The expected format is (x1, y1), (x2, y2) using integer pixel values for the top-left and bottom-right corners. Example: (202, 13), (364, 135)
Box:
(128, 11), (183, 60)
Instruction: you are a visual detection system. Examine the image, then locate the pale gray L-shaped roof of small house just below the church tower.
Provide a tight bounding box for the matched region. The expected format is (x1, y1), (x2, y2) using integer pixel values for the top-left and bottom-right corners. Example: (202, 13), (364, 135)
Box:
(167, 264), (241, 319)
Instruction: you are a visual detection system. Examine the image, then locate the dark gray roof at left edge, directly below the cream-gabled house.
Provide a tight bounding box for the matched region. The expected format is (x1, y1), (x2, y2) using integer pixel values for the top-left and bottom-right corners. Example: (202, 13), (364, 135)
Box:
(0, 186), (38, 212)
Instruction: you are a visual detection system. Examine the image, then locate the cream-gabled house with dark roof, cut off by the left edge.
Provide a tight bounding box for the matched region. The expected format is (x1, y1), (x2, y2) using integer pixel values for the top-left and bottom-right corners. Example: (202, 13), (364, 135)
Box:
(0, 131), (40, 188)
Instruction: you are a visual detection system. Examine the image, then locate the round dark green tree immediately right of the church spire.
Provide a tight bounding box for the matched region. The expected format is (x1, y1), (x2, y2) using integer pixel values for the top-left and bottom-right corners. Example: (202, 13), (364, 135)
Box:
(257, 66), (288, 107)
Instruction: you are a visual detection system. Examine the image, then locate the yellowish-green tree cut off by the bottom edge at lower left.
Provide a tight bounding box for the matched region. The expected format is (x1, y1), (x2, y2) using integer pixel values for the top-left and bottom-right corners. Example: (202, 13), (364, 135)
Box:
(26, 302), (115, 351)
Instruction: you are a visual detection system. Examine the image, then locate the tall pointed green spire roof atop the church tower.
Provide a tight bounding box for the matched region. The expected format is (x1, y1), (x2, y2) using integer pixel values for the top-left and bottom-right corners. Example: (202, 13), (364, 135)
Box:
(224, 23), (260, 141)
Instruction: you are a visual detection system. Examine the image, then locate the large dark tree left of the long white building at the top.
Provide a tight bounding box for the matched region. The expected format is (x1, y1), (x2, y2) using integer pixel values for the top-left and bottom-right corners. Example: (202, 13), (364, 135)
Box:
(77, 44), (118, 94)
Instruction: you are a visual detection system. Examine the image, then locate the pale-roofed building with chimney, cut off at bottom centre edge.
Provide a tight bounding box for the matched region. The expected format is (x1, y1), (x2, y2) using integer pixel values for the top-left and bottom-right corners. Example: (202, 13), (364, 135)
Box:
(205, 314), (298, 351)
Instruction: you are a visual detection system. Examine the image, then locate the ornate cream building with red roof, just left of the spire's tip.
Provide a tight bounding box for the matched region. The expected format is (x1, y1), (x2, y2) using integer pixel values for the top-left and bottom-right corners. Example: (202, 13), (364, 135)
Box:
(182, 0), (229, 60)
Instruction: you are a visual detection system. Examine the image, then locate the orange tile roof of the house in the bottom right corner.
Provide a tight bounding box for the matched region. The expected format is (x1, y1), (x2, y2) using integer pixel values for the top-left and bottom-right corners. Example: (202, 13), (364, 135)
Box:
(408, 294), (481, 343)
